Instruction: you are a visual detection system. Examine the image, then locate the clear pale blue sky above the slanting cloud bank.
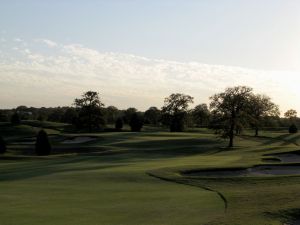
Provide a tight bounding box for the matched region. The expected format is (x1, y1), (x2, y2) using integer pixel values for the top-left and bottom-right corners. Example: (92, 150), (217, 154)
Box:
(0, 0), (300, 70)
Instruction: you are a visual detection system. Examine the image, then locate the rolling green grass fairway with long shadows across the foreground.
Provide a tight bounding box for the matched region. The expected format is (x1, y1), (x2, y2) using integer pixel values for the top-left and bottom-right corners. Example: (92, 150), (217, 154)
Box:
(0, 124), (300, 225)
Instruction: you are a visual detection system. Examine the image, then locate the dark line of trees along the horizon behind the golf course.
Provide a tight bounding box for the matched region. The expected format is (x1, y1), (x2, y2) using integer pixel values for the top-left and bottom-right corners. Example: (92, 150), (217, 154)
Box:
(0, 86), (299, 147)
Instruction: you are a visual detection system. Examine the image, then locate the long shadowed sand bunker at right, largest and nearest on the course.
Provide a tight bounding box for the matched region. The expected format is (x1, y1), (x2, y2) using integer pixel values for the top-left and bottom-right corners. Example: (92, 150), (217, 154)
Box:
(187, 165), (300, 177)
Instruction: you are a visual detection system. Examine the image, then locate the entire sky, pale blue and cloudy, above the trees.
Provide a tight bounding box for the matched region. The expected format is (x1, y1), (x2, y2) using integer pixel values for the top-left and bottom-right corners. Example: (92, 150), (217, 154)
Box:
(0, 0), (300, 112)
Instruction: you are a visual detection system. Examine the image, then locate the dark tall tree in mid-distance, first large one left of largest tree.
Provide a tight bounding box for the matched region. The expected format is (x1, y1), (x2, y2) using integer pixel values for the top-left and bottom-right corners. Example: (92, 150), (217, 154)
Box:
(162, 93), (193, 132)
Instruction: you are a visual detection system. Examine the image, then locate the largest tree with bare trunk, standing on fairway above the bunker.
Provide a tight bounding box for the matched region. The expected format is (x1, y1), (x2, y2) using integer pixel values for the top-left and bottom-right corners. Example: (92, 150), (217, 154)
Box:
(210, 86), (253, 147)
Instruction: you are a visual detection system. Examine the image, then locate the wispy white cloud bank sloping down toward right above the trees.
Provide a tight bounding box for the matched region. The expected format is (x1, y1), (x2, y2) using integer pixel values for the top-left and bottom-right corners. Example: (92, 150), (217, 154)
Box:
(0, 39), (300, 114)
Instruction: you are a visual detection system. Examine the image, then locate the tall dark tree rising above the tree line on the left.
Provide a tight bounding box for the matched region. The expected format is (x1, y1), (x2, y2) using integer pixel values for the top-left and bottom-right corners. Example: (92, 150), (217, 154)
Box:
(74, 91), (104, 131)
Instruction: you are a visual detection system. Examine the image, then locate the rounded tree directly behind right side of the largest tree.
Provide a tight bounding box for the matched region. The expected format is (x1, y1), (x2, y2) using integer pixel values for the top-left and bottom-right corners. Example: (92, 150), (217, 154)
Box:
(248, 95), (280, 136)
